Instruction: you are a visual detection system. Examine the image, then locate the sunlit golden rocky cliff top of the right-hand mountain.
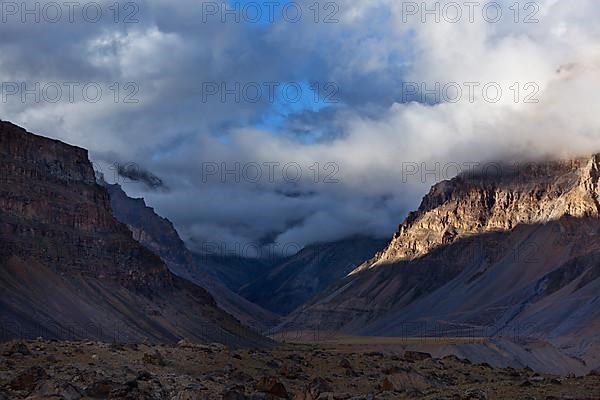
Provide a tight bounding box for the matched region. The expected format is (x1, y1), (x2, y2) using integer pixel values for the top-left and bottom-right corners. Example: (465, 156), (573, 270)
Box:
(352, 154), (600, 274)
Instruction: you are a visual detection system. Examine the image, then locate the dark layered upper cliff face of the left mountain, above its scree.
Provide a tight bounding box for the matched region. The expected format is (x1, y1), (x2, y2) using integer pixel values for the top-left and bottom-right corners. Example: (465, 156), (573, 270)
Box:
(0, 122), (172, 290)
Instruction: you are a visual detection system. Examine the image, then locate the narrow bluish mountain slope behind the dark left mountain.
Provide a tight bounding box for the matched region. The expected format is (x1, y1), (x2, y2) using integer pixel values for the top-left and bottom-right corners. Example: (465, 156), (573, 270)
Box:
(99, 179), (279, 332)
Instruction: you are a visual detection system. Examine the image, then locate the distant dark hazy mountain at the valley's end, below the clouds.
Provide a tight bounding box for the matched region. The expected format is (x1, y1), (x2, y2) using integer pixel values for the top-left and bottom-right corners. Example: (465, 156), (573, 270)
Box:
(239, 237), (386, 315)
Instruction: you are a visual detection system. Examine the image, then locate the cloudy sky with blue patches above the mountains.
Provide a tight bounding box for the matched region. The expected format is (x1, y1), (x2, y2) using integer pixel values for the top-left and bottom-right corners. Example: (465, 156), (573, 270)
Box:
(0, 0), (600, 255)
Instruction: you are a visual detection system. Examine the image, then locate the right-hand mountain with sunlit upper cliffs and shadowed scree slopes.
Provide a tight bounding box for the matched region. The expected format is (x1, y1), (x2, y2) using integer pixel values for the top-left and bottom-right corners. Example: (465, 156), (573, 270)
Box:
(277, 155), (600, 366)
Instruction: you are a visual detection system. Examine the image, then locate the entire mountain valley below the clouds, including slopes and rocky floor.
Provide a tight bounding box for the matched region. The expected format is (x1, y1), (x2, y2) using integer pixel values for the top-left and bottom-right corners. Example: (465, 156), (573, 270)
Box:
(0, 122), (600, 400)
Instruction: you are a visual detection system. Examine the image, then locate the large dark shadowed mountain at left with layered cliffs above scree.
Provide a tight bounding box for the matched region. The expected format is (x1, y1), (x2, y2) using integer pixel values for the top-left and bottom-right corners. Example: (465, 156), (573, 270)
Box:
(0, 122), (268, 346)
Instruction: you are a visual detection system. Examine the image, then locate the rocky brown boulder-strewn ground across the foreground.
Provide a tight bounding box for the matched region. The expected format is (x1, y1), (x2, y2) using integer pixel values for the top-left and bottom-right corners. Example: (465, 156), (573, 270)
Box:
(0, 340), (600, 400)
